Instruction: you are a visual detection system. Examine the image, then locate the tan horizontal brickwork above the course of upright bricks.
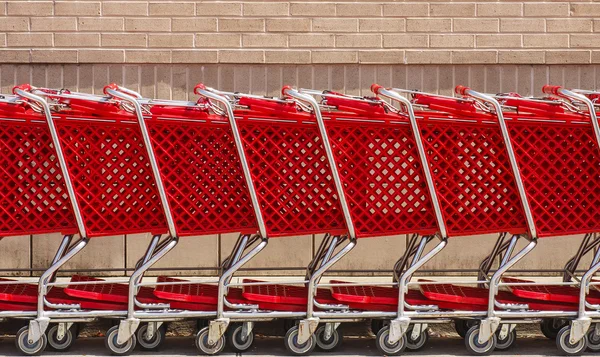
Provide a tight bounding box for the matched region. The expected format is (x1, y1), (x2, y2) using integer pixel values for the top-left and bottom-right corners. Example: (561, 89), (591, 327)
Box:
(0, 0), (600, 64)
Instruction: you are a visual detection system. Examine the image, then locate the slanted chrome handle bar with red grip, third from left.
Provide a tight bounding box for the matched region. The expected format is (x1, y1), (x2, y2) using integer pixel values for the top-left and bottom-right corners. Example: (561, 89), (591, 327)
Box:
(194, 83), (268, 239)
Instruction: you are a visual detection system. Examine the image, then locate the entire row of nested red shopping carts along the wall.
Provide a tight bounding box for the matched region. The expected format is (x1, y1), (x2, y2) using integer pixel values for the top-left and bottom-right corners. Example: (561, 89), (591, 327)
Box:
(0, 84), (600, 355)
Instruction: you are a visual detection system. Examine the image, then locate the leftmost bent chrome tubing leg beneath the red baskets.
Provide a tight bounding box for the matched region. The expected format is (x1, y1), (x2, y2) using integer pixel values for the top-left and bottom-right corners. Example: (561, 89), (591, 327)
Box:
(29, 236), (89, 344)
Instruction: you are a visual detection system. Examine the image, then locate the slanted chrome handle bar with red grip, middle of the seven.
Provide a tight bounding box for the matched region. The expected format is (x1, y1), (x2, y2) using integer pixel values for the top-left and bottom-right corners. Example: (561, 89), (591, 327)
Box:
(281, 86), (356, 240)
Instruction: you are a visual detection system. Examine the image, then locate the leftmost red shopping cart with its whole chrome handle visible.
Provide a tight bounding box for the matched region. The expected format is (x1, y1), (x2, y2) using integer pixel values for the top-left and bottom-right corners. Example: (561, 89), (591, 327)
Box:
(9, 85), (190, 353)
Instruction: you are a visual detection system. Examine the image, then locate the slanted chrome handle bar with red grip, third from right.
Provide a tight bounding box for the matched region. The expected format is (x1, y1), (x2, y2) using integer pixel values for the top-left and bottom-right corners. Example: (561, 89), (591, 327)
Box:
(371, 83), (448, 239)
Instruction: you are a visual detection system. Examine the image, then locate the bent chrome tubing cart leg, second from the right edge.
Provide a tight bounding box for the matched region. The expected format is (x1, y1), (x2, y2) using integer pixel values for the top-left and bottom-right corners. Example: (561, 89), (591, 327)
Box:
(478, 235), (537, 344)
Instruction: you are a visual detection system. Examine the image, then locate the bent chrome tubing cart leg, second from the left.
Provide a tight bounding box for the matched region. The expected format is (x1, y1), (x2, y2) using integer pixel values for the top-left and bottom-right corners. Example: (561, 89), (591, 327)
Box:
(117, 232), (179, 344)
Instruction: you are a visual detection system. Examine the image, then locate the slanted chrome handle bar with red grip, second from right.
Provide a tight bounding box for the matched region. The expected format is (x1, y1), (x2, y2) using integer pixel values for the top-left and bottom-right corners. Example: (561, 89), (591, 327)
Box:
(454, 85), (538, 239)
